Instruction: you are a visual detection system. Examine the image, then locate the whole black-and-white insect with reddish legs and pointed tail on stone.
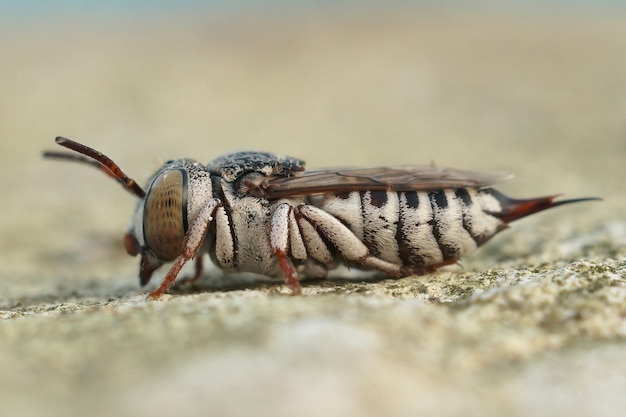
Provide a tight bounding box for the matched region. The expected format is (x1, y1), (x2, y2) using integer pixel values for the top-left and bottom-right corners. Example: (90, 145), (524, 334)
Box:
(44, 137), (597, 298)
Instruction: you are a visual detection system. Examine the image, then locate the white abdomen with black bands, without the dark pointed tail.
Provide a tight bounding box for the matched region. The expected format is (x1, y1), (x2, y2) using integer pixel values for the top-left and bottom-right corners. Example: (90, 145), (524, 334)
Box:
(316, 188), (506, 267)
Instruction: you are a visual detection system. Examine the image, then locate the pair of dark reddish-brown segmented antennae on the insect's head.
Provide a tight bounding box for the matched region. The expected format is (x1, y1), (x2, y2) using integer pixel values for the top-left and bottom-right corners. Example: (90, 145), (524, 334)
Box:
(43, 136), (146, 198)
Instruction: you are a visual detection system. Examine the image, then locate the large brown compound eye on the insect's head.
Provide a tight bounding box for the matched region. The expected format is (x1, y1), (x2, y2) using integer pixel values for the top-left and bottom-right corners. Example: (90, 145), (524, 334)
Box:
(143, 169), (187, 261)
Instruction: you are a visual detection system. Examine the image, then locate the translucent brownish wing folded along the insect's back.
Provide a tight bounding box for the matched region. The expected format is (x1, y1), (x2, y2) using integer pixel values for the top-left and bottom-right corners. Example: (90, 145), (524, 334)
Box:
(250, 166), (510, 199)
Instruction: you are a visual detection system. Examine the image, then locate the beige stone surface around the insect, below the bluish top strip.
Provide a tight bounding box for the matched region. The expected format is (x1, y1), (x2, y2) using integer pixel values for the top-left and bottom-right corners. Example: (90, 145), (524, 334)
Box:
(0, 9), (626, 416)
